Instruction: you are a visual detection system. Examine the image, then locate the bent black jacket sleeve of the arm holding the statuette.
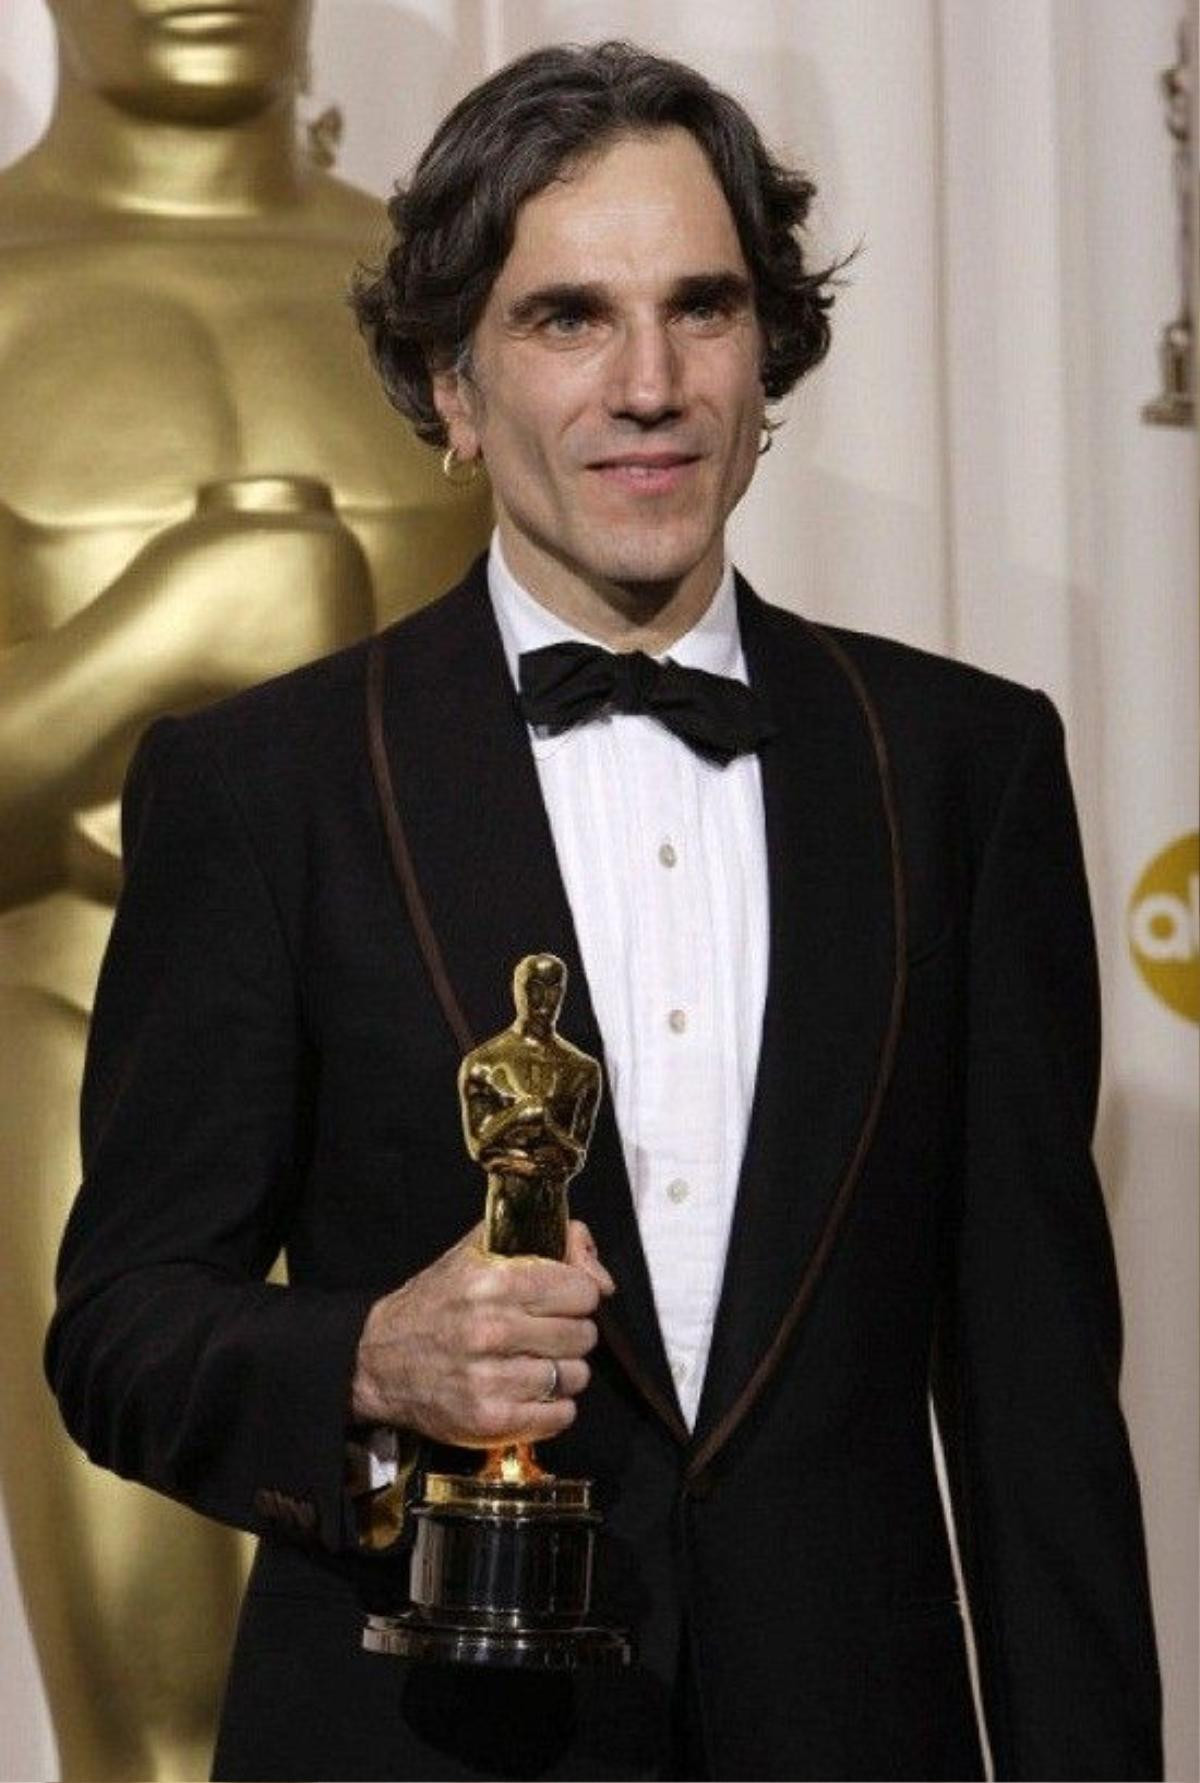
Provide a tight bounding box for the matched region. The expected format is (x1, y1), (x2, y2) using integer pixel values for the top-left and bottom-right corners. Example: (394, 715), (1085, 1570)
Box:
(46, 720), (371, 1549)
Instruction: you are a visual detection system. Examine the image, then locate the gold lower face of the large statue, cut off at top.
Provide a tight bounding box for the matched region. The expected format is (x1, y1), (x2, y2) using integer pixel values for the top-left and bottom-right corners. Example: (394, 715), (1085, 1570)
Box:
(50, 0), (312, 121)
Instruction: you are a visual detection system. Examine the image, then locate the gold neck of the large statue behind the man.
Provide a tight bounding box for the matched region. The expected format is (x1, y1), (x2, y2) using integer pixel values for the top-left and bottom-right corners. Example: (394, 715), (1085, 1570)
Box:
(30, 68), (305, 216)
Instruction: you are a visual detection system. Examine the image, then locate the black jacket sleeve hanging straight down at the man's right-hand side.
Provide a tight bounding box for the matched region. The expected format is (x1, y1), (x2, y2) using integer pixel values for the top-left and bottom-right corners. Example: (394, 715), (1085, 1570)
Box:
(934, 697), (1163, 1779)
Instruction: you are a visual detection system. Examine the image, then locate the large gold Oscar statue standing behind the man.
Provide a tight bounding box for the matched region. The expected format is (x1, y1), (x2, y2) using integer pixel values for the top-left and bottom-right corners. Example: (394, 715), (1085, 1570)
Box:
(0, 0), (485, 1779)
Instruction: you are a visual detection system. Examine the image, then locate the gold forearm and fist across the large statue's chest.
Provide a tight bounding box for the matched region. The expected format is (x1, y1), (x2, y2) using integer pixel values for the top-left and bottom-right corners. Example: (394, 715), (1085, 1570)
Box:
(0, 484), (373, 909)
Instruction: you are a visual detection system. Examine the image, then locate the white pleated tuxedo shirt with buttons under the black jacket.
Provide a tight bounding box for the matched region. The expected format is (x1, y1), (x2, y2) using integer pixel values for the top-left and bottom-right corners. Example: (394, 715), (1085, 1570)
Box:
(489, 538), (768, 1425)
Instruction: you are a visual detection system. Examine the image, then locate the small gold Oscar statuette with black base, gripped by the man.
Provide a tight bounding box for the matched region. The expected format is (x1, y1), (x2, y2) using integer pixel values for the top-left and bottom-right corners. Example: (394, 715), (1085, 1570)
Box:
(362, 954), (631, 1671)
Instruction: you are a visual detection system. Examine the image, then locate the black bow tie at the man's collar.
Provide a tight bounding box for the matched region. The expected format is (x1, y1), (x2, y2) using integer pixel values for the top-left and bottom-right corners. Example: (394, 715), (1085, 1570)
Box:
(519, 644), (776, 767)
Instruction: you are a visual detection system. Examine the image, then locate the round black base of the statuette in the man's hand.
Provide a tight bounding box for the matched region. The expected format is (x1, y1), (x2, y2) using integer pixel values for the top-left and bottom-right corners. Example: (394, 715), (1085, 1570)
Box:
(362, 1475), (633, 1671)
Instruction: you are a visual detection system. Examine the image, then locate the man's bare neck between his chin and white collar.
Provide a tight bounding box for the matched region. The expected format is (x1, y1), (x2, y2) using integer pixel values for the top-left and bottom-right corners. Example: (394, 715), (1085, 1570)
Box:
(499, 517), (726, 656)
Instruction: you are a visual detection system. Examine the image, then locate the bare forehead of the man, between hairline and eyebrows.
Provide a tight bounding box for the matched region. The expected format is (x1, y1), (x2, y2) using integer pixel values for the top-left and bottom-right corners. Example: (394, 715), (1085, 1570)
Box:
(496, 127), (745, 298)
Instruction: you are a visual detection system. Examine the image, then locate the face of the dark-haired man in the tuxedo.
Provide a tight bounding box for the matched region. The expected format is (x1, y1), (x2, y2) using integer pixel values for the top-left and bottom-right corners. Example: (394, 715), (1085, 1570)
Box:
(435, 127), (763, 627)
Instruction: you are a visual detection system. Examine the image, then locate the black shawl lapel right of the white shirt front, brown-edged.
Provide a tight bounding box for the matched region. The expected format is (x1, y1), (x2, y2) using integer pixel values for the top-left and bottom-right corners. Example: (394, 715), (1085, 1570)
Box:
(688, 581), (904, 1482)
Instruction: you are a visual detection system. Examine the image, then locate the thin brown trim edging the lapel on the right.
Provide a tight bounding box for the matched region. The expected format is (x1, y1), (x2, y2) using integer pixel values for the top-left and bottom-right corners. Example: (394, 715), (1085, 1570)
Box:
(686, 620), (908, 1487)
